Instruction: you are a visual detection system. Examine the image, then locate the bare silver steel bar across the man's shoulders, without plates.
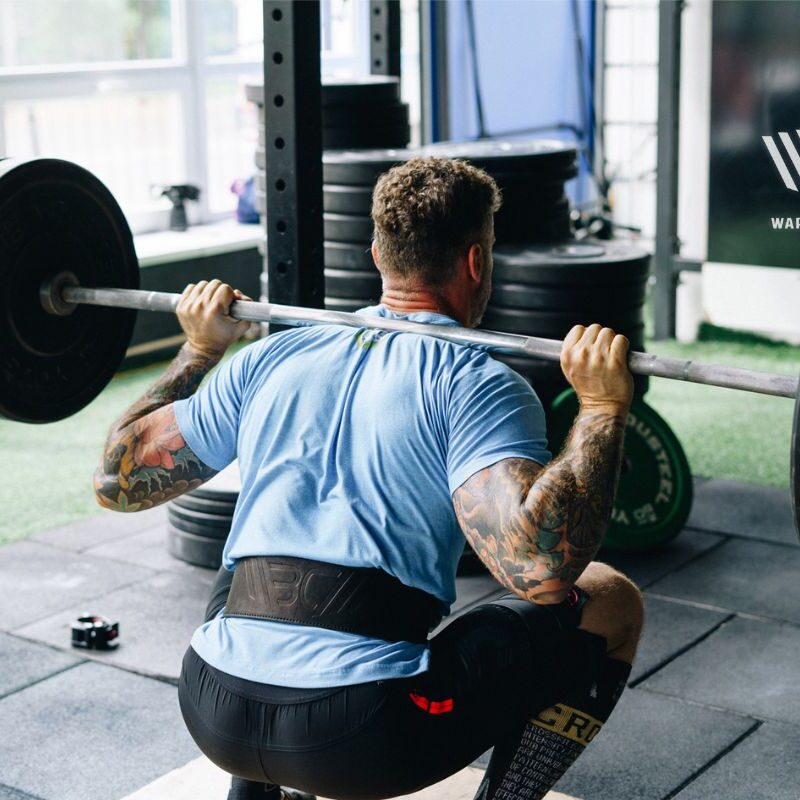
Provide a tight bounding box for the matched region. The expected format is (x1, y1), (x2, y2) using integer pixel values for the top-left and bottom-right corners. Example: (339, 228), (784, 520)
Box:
(62, 286), (798, 399)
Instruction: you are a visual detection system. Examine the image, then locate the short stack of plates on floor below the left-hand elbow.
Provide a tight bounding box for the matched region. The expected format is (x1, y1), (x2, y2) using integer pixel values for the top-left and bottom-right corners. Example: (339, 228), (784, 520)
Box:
(167, 463), (242, 569)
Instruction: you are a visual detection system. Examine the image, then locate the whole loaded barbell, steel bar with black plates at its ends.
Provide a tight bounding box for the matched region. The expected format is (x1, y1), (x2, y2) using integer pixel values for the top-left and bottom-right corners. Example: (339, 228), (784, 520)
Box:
(0, 159), (800, 532)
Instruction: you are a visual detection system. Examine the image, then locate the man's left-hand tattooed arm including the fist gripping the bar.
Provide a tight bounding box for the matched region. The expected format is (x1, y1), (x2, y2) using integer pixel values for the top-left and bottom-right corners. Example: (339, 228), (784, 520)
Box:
(94, 280), (247, 511)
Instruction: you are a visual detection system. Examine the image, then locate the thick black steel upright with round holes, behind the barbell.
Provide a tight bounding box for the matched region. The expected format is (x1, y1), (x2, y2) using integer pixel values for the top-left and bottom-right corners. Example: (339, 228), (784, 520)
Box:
(264, 0), (325, 308)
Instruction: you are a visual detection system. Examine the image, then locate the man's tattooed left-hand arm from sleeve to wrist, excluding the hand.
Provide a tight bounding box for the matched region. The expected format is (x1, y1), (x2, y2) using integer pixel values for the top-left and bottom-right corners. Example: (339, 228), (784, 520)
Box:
(94, 345), (217, 511)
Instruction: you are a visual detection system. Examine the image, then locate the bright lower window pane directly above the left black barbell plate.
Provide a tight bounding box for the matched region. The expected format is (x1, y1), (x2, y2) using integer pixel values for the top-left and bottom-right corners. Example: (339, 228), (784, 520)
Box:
(3, 91), (186, 215)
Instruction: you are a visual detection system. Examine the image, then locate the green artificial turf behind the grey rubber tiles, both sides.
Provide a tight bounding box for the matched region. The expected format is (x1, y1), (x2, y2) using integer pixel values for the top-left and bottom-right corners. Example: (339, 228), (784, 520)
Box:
(0, 326), (800, 543)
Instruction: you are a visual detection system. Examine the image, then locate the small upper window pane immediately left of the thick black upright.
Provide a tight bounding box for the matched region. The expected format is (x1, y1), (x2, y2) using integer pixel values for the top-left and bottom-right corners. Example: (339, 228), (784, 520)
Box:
(203, 0), (264, 61)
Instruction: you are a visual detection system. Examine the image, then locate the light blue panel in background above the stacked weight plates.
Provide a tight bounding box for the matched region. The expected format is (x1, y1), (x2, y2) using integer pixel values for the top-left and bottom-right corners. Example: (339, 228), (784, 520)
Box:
(447, 0), (596, 209)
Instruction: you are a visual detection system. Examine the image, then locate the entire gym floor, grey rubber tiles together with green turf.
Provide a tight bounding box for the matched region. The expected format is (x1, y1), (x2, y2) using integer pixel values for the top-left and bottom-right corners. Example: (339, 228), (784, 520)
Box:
(0, 326), (800, 800)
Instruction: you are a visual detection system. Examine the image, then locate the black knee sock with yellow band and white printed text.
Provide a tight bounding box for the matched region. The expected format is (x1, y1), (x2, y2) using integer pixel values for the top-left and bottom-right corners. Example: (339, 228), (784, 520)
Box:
(475, 658), (631, 800)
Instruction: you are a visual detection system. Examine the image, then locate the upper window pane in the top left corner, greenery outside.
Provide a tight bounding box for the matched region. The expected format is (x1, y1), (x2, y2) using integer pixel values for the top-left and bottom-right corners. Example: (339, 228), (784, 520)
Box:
(0, 0), (174, 68)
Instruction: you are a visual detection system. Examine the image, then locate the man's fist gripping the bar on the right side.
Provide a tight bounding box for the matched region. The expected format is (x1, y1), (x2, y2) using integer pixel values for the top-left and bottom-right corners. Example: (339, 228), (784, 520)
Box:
(561, 325), (633, 413)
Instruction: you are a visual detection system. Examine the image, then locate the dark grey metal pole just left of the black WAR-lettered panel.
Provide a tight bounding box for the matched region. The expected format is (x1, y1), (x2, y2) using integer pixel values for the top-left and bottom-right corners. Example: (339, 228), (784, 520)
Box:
(653, 0), (683, 339)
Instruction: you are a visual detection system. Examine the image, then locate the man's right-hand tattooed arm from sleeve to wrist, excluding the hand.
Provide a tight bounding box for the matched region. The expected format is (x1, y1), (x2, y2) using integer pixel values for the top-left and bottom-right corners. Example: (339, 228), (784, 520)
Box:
(453, 412), (625, 603)
